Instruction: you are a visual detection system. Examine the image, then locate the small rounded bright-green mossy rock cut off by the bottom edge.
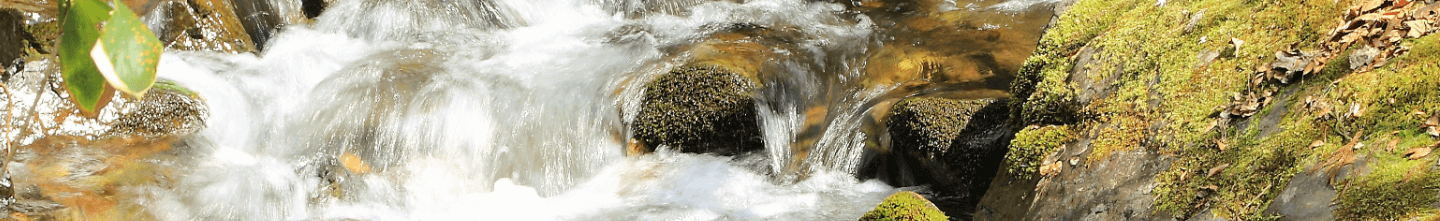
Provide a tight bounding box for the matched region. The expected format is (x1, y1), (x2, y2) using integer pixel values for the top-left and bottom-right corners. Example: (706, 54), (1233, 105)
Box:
(860, 191), (948, 221)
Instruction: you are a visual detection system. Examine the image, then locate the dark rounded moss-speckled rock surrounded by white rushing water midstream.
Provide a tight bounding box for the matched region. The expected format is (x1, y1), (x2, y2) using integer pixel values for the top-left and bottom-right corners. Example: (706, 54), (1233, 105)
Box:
(632, 65), (763, 155)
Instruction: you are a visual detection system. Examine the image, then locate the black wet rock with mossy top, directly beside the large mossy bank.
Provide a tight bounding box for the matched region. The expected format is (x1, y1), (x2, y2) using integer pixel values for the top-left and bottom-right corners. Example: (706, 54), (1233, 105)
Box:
(861, 97), (1014, 217)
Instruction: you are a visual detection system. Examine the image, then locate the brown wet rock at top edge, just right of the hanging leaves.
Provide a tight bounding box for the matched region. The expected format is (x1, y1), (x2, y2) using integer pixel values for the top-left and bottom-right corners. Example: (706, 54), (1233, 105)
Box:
(141, 0), (256, 53)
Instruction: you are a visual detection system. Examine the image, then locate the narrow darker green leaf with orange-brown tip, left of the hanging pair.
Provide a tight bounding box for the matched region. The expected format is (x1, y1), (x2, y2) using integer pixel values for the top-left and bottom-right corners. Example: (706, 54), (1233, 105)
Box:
(60, 0), (109, 116)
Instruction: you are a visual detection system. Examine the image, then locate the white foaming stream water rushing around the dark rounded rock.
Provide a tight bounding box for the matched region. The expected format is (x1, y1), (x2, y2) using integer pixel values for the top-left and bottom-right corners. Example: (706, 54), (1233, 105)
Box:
(137, 0), (1059, 220)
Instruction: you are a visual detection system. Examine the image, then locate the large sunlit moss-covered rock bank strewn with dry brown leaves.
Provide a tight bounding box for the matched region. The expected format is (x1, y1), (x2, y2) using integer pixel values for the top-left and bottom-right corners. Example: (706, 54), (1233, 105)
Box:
(1008, 0), (1440, 220)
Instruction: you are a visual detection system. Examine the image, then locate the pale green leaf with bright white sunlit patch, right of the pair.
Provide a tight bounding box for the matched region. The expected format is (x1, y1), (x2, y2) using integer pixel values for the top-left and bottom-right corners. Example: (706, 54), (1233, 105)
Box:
(91, 1), (161, 98)
